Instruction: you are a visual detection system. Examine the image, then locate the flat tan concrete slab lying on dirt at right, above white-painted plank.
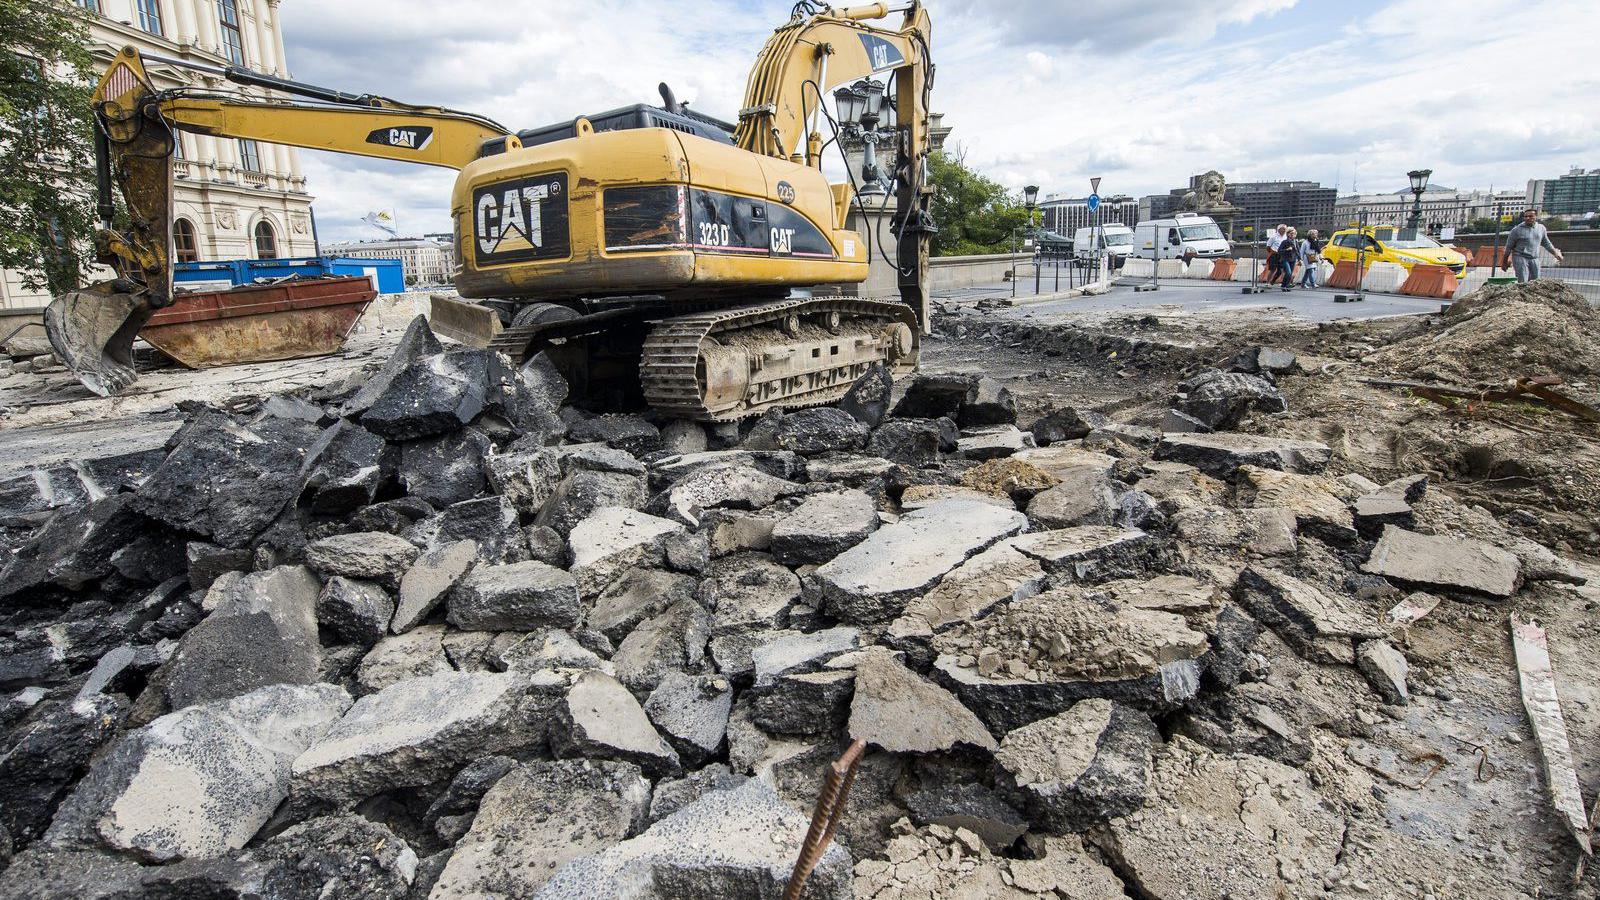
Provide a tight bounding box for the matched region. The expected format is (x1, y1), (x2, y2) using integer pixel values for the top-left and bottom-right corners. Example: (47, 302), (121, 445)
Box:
(1362, 525), (1522, 599)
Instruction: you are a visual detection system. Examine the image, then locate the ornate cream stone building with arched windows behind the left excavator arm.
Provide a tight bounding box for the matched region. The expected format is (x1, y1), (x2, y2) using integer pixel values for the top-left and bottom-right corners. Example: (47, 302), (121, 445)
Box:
(0, 0), (315, 307)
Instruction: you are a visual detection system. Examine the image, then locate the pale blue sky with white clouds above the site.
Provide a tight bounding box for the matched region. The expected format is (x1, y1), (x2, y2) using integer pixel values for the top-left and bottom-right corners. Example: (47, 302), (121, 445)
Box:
(283, 0), (1600, 239)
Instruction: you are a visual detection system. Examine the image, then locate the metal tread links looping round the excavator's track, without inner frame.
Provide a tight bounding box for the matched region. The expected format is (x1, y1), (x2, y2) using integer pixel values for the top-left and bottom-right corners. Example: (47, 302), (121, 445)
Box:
(638, 298), (917, 421)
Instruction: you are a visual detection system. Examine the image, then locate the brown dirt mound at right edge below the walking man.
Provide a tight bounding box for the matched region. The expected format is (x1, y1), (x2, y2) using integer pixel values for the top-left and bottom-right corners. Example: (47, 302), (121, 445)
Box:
(1376, 282), (1600, 386)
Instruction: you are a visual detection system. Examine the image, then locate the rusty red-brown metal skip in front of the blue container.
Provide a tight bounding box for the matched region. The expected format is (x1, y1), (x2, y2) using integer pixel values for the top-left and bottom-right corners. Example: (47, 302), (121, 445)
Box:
(139, 277), (378, 368)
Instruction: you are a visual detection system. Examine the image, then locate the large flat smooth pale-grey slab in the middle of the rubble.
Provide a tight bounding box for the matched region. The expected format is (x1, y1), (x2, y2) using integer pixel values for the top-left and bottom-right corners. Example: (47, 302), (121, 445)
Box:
(814, 500), (1027, 625)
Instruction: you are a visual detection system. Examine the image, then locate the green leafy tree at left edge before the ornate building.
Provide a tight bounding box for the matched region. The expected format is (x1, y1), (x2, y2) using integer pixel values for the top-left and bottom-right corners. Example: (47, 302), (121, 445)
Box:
(0, 0), (94, 293)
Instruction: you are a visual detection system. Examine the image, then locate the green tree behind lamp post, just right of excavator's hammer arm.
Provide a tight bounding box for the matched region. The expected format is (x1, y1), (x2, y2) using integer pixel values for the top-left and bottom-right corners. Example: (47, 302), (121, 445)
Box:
(928, 151), (1027, 256)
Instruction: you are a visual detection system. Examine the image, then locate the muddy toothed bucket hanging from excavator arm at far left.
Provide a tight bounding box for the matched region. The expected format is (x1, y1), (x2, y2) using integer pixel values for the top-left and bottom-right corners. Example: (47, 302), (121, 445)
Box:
(45, 280), (152, 397)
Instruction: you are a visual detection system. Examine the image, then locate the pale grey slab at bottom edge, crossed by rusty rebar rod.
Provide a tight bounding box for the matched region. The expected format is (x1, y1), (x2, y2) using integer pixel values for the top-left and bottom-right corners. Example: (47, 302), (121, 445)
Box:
(533, 780), (854, 900)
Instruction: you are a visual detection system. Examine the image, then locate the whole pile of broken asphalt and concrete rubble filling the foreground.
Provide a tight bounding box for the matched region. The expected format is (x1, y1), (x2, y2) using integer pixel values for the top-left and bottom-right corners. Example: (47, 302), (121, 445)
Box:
(0, 312), (1582, 900)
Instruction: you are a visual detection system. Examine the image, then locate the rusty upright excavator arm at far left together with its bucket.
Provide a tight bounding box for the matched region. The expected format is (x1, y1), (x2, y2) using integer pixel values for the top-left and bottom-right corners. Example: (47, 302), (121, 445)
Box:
(45, 46), (173, 397)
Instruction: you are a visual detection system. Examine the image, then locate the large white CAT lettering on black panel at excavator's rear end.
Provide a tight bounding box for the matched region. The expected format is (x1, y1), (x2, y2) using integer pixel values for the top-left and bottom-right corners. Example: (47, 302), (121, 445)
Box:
(472, 173), (568, 264)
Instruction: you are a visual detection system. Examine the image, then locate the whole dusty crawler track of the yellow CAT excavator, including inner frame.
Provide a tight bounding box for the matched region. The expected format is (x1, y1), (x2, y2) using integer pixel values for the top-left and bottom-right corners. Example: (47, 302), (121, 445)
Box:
(638, 298), (918, 421)
